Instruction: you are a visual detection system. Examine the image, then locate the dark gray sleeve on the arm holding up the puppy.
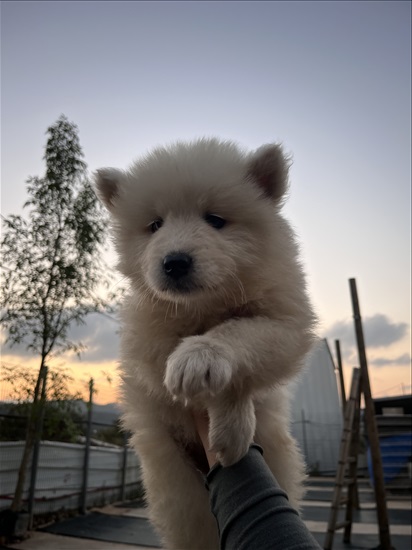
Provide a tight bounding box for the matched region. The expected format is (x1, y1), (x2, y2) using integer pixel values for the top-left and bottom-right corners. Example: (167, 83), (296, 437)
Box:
(206, 445), (320, 550)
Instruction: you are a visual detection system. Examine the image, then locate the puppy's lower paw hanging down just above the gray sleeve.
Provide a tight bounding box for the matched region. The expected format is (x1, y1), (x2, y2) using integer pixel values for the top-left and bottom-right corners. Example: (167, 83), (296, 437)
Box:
(209, 399), (256, 466)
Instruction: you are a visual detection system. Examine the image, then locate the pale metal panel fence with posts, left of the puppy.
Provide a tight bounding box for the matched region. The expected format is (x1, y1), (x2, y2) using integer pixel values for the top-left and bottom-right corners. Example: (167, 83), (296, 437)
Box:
(0, 414), (141, 523)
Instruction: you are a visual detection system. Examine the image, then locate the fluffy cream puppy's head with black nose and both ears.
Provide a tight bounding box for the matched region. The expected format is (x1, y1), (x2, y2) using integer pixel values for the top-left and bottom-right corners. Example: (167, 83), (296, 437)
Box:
(95, 139), (288, 306)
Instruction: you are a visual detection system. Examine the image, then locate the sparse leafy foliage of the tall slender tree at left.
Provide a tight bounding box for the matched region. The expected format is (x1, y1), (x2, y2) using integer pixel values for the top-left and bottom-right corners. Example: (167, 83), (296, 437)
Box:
(0, 116), (107, 365)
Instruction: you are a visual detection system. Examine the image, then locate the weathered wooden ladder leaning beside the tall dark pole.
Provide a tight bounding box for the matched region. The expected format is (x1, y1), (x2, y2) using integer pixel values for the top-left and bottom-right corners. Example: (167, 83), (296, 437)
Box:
(323, 369), (361, 550)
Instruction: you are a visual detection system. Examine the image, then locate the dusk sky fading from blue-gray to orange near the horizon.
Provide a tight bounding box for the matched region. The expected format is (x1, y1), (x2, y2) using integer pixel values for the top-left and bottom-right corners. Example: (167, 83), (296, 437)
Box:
(1, 1), (411, 401)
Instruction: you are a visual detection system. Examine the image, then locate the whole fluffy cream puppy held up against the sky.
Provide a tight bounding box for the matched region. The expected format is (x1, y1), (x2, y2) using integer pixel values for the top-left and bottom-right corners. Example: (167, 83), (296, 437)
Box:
(96, 139), (315, 550)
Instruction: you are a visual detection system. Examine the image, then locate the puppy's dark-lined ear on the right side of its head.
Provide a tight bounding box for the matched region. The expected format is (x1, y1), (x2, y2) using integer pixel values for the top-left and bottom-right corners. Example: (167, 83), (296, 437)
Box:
(247, 143), (290, 202)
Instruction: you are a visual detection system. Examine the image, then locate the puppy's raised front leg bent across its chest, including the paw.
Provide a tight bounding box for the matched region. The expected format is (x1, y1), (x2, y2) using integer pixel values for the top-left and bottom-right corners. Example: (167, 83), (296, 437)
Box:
(165, 317), (314, 400)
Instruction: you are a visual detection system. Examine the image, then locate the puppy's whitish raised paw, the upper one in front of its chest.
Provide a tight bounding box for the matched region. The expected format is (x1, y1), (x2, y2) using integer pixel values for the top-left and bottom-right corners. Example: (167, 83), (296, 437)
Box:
(164, 336), (234, 400)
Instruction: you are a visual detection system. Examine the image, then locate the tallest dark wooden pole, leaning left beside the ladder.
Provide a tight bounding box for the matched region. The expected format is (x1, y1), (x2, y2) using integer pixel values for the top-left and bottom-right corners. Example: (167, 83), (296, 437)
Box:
(349, 279), (392, 550)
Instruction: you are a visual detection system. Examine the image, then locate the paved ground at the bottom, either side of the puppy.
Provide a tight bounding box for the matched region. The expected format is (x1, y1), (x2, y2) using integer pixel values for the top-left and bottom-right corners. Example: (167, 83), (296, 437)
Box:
(7, 477), (412, 550)
